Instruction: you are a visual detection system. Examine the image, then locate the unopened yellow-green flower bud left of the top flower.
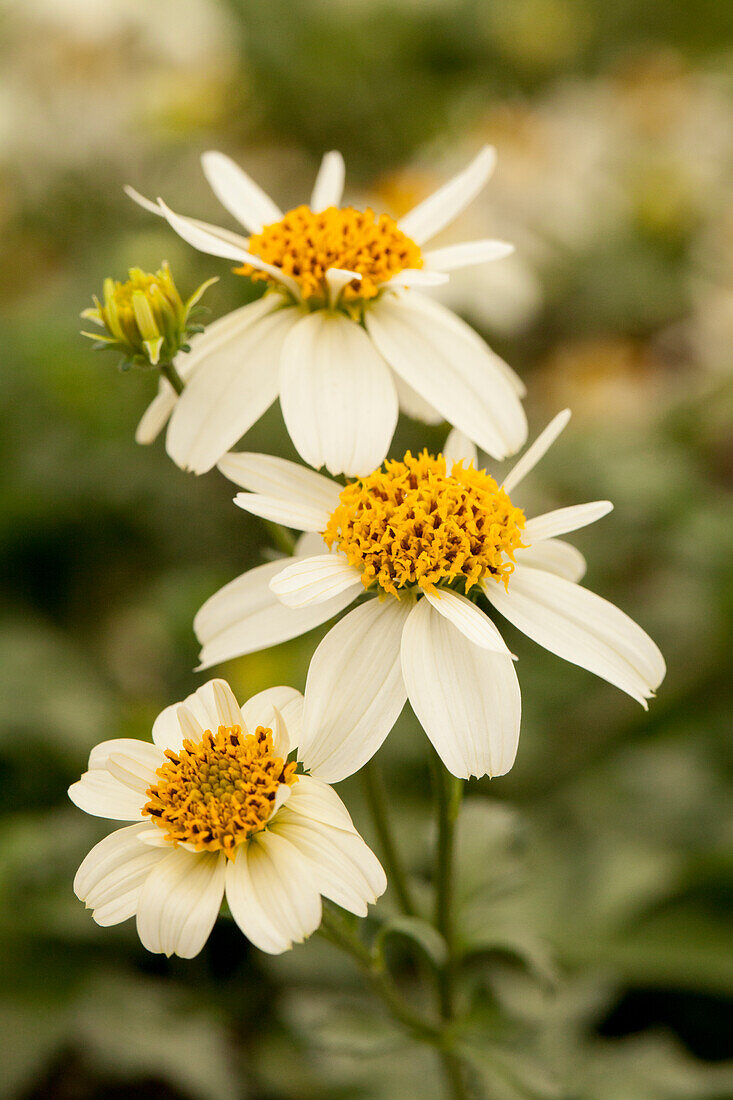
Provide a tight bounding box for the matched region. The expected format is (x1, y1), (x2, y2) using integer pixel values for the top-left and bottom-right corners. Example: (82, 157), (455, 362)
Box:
(81, 263), (217, 366)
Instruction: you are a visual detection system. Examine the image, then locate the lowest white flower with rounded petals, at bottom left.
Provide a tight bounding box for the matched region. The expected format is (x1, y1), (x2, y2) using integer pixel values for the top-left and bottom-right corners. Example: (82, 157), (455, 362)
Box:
(68, 680), (386, 958)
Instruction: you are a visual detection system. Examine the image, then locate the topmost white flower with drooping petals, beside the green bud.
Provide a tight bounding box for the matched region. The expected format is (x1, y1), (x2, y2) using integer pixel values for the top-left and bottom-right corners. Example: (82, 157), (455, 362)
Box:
(128, 147), (527, 475)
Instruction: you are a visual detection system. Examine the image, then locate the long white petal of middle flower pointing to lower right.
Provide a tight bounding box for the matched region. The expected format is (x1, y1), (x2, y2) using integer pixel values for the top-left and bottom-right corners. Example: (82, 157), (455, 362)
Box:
(484, 565), (665, 706)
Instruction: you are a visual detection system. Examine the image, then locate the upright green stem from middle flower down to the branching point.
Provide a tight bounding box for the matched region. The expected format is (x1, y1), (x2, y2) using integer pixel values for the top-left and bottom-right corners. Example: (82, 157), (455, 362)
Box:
(430, 750), (463, 1020)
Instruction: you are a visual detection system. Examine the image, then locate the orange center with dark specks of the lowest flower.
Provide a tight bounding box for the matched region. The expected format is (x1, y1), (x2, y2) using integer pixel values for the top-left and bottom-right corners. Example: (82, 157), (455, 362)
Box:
(143, 726), (297, 859)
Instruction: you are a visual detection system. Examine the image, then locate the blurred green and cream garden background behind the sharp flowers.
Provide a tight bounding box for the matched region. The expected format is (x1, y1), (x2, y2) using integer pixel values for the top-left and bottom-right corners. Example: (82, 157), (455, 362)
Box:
(0, 0), (733, 1100)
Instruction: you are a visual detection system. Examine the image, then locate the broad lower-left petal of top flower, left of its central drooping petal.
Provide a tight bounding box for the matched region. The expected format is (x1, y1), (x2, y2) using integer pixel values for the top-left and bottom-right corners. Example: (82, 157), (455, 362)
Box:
(166, 295), (300, 474)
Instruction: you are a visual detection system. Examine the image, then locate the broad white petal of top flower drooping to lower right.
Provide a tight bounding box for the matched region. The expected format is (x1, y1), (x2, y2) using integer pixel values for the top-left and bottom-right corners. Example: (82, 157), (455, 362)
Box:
(365, 290), (527, 459)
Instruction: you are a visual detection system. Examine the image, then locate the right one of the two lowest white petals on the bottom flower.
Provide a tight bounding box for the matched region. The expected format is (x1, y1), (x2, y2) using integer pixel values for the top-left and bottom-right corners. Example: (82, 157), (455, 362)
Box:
(227, 829), (321, 955)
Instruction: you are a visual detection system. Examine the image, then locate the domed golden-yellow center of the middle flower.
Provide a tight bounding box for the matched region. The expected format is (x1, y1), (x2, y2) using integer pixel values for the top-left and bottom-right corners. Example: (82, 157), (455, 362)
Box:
(324, 451), (525, 595)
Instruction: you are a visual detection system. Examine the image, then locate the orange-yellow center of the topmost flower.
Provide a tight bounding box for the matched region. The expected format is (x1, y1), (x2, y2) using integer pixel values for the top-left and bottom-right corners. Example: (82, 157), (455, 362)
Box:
(238, 206), (423, 301)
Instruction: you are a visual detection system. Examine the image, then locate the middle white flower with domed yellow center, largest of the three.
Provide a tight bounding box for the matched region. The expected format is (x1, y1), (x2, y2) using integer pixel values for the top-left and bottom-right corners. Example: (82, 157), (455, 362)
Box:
(194, 410), (665, 782)
